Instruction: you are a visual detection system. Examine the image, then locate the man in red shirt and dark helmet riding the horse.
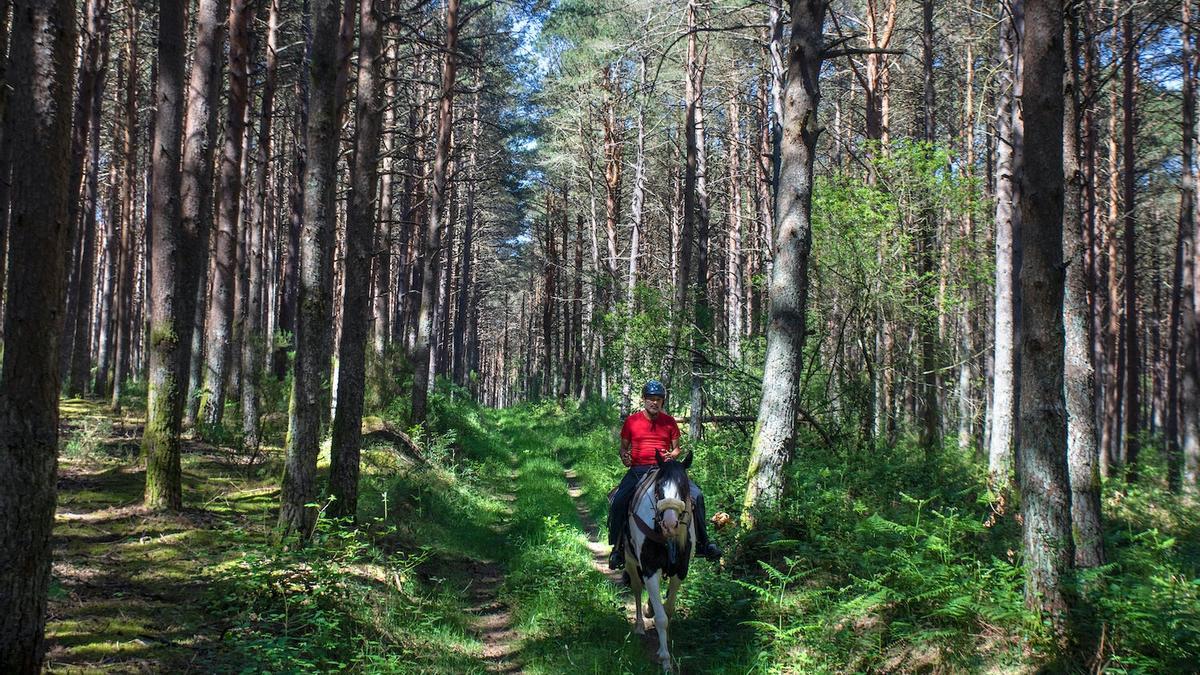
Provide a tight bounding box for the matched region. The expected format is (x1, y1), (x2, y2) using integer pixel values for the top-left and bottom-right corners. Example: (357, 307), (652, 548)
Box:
(608, 380), (721, 569)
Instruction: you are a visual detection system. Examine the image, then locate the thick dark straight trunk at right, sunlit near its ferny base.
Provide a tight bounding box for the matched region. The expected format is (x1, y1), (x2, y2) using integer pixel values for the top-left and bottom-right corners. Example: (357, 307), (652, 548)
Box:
(1016, 0), (1074, 641)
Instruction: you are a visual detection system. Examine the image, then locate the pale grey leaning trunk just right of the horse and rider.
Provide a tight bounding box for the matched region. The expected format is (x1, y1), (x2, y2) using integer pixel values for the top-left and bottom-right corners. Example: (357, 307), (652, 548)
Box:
(743, 0), (829, 526)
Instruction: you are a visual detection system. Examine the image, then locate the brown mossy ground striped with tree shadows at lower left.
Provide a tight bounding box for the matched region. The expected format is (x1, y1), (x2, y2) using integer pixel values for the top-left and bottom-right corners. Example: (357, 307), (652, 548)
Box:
(46, 399), (278, 673)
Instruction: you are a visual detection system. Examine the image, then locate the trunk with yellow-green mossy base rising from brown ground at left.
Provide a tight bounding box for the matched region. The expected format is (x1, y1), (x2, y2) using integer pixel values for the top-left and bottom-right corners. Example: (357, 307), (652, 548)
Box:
(142, 1), (187, 510)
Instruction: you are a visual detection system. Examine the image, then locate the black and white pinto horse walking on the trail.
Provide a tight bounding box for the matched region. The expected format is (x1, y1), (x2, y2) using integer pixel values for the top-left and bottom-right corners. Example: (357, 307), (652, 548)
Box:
(625, 453), (696, 673)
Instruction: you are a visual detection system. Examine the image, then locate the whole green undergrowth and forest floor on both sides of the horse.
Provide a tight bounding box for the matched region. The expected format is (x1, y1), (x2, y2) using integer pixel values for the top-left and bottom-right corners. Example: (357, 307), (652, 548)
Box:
(48, 394), (1200, 674)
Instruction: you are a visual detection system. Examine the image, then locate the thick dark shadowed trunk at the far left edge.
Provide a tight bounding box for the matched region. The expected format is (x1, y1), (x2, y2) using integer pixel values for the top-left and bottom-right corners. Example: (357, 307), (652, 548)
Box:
(0, 0), (76, 673)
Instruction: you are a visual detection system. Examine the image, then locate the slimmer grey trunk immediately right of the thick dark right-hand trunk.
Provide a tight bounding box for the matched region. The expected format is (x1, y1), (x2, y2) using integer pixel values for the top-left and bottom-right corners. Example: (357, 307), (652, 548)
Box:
(1062, 6), (1104, 568)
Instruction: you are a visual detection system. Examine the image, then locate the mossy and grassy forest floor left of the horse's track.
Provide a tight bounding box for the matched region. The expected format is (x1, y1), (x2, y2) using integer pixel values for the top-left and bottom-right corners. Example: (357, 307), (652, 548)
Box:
(46, 400), (729, 673)
